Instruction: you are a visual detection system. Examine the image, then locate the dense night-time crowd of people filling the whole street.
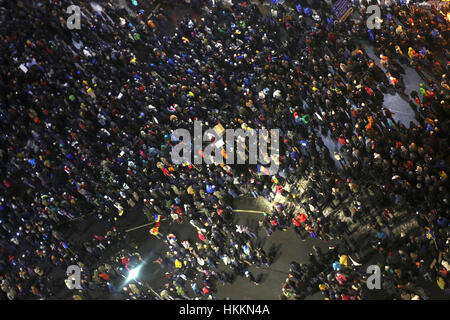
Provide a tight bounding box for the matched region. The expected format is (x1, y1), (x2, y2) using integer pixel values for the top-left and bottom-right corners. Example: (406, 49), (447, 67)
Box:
(0, 0), (450, 300)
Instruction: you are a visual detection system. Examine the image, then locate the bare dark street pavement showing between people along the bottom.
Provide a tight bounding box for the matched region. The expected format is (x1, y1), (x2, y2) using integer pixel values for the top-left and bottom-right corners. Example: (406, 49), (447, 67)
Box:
(116, 198), (338, 300)
